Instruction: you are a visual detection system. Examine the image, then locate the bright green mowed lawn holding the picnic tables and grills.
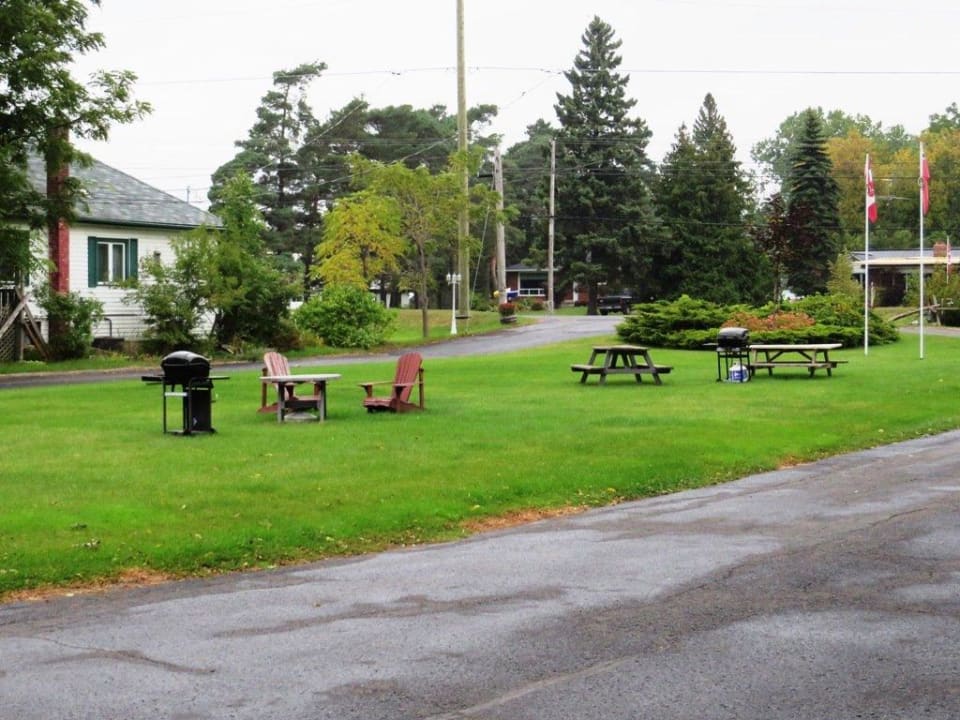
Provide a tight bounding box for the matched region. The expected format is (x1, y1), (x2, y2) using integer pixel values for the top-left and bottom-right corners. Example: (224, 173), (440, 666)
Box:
(0, 336), (960, 596)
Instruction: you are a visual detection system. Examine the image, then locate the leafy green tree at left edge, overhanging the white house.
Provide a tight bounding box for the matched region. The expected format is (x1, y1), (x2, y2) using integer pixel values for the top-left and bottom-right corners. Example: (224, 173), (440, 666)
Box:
(0, 0), (150, 284)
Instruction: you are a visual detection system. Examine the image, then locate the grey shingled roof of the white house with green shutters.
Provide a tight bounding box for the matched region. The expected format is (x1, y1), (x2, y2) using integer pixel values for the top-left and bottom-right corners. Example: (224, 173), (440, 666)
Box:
(28, 157), (223, 230)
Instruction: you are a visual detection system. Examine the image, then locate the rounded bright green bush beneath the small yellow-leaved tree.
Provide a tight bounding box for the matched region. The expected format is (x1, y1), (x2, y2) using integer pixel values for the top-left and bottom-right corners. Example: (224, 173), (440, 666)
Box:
(293, 285), (394, 350)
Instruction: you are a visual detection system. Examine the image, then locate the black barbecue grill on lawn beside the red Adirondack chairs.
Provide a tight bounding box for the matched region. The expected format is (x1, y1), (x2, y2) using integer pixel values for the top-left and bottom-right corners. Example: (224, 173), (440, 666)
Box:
(142, 350), (227, 435)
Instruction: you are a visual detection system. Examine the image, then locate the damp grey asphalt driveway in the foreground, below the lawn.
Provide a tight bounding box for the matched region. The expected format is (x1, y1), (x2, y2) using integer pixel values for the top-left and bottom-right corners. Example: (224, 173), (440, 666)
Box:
(0, 433), (960, 720)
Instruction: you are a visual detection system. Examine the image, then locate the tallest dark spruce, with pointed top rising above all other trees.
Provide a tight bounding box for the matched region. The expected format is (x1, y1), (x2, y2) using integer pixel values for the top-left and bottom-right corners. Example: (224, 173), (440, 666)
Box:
(554, 17), (660, 314)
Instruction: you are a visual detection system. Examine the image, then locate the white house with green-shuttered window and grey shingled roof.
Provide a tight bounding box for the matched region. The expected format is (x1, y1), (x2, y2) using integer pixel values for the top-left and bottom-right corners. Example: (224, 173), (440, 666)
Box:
(29, 159), (222, 339)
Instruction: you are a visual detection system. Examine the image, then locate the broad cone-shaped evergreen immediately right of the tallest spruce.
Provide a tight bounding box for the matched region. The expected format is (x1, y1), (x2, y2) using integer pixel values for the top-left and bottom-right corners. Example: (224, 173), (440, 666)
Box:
(657, 94), (766, 303)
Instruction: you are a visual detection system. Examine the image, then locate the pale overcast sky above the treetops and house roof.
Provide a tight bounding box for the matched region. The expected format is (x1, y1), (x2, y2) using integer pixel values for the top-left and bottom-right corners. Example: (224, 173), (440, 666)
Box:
(78, 0), (960, 205)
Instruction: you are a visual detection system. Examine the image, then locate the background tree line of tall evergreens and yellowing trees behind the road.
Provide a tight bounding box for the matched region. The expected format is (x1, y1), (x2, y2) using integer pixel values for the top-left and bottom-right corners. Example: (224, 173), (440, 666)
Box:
(204, 18), (960, 310)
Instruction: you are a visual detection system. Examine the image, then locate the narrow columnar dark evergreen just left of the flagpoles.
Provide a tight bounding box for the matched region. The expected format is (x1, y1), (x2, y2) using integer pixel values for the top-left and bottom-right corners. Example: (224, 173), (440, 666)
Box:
(784, 110), (840, 295)
